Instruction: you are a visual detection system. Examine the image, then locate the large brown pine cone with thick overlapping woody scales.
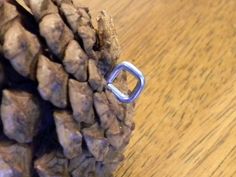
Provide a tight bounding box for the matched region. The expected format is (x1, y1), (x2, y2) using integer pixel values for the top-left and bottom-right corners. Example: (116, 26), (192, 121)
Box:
(0, 0), (134, 177)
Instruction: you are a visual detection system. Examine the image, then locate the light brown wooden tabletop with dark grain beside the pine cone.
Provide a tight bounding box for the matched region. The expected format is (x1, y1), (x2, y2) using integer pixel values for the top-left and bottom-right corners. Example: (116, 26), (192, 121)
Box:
(19, 0), (236, 177)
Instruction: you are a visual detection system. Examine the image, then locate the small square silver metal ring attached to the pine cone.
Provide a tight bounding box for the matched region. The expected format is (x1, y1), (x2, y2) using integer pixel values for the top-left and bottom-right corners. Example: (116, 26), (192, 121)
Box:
(107, 61), (145, 103)
